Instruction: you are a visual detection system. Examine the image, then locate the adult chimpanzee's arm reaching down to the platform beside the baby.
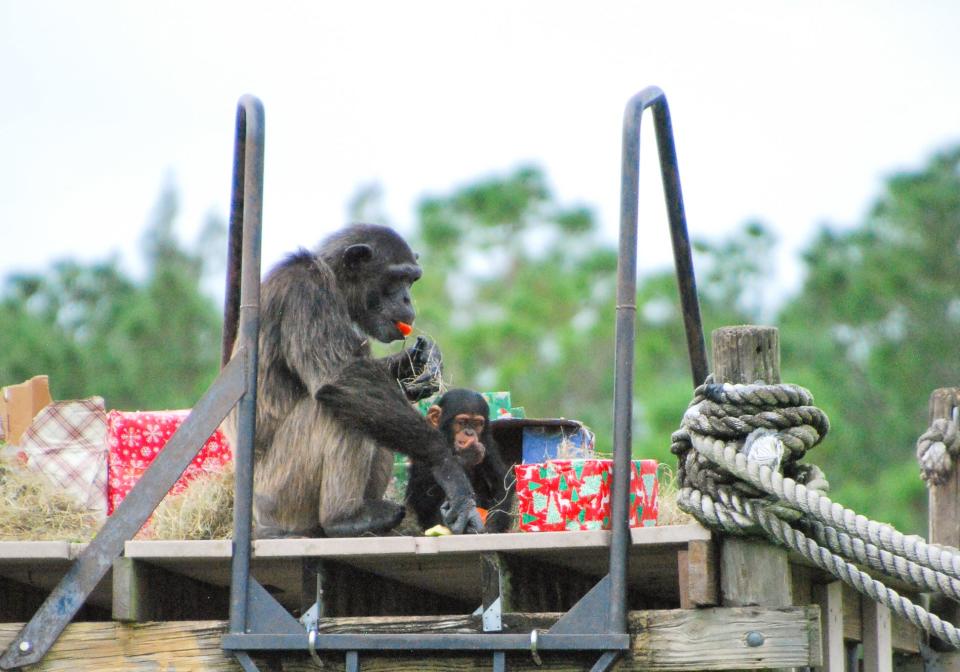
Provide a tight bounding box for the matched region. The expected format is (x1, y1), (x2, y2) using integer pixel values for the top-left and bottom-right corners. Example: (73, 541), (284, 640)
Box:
(314, 359), (483, 533)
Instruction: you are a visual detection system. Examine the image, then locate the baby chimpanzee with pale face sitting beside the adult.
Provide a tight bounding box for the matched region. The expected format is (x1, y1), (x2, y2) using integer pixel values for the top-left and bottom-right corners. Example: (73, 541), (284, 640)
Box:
(406, 389), (513, 532)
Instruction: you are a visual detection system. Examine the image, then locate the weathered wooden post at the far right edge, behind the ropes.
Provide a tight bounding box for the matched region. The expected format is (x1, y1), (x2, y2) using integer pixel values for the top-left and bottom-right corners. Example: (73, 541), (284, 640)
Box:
(927, 387), (960, 672)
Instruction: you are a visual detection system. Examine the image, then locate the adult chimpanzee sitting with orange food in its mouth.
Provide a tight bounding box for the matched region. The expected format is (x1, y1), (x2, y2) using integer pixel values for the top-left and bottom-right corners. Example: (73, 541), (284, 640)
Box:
(237, 224), (482, 537)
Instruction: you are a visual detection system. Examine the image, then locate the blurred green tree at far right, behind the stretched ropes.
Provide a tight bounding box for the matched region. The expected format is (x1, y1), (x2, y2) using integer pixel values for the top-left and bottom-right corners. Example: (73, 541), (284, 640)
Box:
(781, 148), (960, 532)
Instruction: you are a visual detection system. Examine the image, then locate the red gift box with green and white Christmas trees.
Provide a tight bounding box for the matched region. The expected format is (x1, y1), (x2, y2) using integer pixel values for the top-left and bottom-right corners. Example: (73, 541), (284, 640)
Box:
(514, 460), (659, 532)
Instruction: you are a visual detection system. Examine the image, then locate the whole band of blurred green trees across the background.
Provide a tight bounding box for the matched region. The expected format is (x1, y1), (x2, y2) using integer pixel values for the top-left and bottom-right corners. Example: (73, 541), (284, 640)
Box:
(0, 148), (960, 532)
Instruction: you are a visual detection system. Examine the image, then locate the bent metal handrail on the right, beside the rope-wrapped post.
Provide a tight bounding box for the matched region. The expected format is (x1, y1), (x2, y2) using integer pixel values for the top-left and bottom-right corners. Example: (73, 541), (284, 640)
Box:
(610, 86), (708, 632)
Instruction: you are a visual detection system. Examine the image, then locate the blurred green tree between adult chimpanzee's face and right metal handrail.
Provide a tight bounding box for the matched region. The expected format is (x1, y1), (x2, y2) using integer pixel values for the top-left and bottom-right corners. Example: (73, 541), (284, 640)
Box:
(412, 166), (616, 452)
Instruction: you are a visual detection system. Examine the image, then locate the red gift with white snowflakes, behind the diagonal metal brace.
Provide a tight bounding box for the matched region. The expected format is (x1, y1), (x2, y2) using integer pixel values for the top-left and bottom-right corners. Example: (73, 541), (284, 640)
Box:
(107, 411), (233, 515)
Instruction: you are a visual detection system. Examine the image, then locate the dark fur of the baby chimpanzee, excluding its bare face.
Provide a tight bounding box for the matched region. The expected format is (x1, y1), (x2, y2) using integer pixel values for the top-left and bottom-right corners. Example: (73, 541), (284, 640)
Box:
(406, 389), (513, 532)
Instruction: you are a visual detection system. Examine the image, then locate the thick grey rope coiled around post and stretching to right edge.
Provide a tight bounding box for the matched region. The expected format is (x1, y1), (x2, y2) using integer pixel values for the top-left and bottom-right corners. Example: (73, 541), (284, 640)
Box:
(671, 379), (960, 648)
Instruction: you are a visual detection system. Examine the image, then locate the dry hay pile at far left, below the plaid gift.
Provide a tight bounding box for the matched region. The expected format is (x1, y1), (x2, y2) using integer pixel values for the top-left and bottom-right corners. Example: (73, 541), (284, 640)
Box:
(0, 460), (101, 541)
